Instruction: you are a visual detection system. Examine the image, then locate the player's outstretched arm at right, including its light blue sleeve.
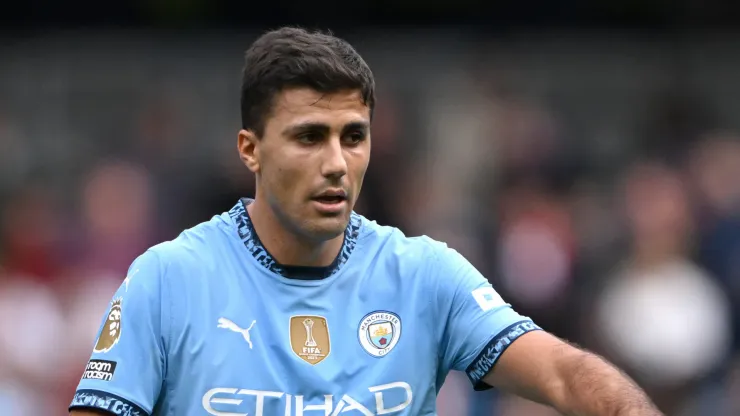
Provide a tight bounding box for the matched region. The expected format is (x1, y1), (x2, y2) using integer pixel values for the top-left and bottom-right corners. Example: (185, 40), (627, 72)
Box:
(427, 242), (662, 416)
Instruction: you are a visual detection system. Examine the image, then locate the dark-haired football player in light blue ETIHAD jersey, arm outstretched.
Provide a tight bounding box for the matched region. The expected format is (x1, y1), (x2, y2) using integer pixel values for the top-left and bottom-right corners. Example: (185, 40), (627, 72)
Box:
(70, 28), (660, 416)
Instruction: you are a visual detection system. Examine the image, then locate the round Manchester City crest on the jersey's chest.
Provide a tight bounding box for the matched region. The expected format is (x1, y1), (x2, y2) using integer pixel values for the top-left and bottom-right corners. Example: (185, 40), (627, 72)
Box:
(357, 311), (401, 358)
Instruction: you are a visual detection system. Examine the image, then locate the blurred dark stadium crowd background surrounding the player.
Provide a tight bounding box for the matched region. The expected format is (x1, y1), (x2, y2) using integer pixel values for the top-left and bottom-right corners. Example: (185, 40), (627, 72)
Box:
(0, 0), (740, 416)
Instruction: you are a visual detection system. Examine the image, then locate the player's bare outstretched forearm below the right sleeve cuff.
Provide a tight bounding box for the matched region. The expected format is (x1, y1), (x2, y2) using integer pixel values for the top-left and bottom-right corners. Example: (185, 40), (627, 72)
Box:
(483, 331), (663, 416)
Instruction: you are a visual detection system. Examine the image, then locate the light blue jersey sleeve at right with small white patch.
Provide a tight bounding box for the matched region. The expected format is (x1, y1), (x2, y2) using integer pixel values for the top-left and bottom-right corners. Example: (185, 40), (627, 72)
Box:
(431, 247), (540, 390)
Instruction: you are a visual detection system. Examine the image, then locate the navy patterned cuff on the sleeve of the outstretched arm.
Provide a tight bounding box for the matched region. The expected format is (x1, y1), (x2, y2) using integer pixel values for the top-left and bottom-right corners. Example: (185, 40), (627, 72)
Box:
(465, 320), (541, 391)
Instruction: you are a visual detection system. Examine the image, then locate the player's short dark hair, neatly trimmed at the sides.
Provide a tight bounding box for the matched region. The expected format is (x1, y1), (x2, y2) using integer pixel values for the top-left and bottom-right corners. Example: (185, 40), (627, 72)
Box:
(241, 27), (375, 136)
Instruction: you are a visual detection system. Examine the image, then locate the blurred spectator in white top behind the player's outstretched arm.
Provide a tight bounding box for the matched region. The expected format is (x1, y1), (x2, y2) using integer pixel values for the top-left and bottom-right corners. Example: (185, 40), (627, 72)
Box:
(596, 163), (730, 414)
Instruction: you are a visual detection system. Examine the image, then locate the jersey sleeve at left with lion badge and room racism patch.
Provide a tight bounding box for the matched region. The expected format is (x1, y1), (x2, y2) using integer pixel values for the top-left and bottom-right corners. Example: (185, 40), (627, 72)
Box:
(69, 251), (169, 416)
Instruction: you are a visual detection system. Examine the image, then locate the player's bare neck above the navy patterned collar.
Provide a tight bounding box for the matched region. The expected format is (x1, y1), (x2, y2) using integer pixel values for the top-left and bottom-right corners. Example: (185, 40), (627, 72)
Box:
(246, 198), (344, 267)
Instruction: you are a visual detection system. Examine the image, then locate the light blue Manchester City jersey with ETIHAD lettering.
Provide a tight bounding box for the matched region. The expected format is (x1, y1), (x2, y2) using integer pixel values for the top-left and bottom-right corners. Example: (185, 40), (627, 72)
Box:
(71, 200), (539, 416)
